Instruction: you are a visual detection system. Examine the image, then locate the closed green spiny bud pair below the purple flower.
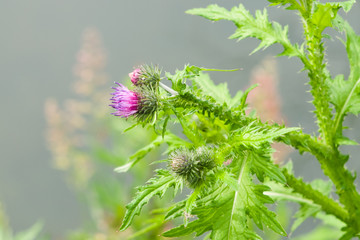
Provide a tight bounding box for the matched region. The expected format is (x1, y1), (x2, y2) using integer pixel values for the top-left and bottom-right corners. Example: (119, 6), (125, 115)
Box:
(170, 147), (216, 188)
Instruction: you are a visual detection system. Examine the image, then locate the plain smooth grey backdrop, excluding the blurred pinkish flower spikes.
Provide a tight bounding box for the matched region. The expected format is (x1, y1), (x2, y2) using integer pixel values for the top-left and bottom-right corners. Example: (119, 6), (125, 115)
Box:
(0, 0), (360, 239)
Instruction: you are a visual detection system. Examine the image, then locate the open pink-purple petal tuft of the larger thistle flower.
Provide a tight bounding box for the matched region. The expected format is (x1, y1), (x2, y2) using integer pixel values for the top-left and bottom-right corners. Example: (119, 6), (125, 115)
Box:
(110, 82), (140, 118)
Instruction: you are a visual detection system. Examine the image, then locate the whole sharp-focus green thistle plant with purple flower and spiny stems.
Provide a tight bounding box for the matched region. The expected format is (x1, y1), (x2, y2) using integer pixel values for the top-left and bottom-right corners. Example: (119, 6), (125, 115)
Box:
(112, 0), (360, 240)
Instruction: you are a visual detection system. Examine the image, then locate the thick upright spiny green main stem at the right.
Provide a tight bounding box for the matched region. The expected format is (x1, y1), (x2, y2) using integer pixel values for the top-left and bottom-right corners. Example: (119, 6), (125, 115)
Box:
(292, 0), (360, 232)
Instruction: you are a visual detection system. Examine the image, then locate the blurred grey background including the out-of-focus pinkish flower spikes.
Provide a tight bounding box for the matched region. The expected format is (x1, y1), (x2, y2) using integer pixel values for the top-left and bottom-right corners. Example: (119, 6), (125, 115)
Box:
(0, 0), (360, 239)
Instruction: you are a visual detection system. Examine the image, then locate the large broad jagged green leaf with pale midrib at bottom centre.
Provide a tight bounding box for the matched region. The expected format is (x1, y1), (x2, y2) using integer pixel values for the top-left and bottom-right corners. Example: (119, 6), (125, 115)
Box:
(164, 153), (286, 240)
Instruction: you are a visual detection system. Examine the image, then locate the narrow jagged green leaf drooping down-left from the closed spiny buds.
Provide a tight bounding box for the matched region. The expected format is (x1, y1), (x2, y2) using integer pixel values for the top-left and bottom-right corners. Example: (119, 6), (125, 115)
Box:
(120, 170), (181, 231)
